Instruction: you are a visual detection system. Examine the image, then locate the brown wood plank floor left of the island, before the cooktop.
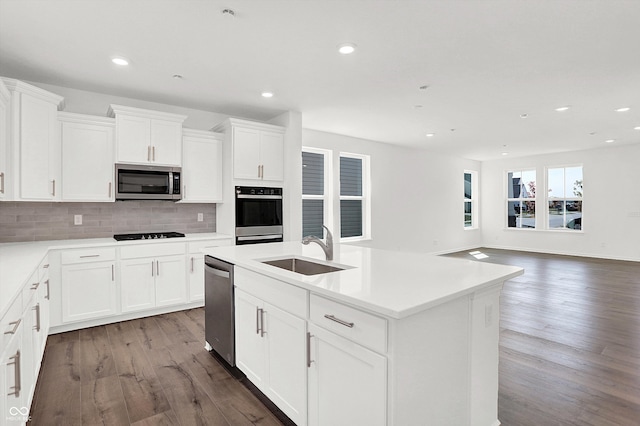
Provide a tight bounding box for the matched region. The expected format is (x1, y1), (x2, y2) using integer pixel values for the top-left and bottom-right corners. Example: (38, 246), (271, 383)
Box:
(31, 308), (282, 426)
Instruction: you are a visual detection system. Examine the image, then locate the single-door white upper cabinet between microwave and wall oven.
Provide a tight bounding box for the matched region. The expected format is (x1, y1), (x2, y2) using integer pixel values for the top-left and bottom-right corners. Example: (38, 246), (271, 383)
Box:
(182, 129), (223, 203)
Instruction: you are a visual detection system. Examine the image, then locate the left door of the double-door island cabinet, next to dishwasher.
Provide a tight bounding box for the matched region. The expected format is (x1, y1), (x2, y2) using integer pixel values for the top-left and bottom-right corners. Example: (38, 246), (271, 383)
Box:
(235, 288), (266, 392)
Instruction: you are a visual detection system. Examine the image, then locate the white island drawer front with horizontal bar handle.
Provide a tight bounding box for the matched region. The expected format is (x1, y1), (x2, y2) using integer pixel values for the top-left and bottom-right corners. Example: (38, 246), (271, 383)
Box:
(309, 294), (387, 353)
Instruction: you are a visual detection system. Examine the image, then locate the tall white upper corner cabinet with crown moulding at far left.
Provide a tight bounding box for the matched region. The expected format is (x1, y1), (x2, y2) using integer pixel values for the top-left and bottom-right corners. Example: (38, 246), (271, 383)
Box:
(0, 78), (64, 201)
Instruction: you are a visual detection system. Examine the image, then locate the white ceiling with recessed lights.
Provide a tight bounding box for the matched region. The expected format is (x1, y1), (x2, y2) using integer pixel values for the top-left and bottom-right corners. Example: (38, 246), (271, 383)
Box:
(0, 0), (640, 160)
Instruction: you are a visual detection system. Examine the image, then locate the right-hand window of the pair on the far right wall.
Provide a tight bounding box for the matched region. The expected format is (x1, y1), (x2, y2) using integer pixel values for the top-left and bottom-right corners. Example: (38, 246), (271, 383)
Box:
(547, 166), (582, 230)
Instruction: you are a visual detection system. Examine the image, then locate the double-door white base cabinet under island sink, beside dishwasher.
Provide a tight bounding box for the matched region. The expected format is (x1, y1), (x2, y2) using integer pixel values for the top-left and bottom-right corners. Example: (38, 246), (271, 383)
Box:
(235, 289), (307, 426)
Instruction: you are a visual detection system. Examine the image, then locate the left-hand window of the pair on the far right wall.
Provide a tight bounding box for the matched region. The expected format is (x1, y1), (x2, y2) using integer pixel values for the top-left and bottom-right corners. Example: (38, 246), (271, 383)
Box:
(507, 170), (536, 228)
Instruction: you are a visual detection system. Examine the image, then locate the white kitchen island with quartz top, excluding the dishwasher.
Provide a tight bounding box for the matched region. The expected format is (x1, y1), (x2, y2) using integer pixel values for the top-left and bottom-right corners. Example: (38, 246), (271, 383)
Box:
(204, 242), (523, 426)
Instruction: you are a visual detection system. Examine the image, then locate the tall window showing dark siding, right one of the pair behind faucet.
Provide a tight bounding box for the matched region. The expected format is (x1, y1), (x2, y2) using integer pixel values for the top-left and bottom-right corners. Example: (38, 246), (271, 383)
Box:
(340, 153), (367, 239)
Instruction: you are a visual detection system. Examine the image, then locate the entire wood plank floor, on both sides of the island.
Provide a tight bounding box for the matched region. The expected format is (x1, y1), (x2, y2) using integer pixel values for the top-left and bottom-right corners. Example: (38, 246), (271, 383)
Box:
(31, 249), (640, 426)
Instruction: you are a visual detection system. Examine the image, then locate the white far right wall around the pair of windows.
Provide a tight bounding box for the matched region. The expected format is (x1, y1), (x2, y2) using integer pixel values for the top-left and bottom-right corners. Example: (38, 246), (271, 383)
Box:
(480, 145), (640, 260)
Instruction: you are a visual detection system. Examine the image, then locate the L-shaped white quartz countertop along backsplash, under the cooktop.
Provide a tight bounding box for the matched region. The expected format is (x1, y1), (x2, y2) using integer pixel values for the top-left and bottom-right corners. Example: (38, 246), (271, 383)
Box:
(0, 232), (232, 318)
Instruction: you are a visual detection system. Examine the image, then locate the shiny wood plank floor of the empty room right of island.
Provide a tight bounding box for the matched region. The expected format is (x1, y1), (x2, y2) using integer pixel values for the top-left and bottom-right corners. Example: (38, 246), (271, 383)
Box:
(450, 249), (640, 426)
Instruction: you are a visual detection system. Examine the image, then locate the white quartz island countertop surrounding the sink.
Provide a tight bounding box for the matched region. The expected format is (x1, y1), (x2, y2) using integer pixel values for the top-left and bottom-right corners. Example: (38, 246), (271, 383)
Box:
(203, 241), (524, 319)
